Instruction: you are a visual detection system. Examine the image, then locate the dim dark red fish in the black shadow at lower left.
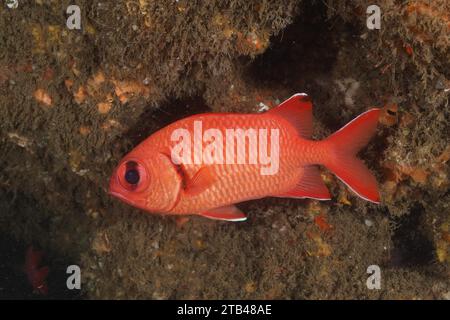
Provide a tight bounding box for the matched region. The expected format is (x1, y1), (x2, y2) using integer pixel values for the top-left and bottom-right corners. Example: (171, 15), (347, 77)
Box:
(25, 246), (49, 295)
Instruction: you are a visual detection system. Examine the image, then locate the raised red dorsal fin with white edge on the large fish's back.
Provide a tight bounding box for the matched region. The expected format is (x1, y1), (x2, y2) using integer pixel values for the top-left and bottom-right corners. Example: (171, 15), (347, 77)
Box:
(267, 93), (312, 139)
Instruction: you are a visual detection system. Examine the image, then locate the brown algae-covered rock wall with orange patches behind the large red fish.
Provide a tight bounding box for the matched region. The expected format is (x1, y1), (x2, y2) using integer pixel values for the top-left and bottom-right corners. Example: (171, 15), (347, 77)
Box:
(0, 0), (450, 299)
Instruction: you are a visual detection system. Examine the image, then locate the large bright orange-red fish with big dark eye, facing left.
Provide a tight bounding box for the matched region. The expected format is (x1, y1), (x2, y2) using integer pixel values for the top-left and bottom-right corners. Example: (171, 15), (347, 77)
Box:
(109, 94), (380, 221)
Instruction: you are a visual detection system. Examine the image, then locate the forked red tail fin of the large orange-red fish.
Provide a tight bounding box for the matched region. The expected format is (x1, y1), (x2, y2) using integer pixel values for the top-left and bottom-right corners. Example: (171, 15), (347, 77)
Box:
(324, 109), (380, 203)
